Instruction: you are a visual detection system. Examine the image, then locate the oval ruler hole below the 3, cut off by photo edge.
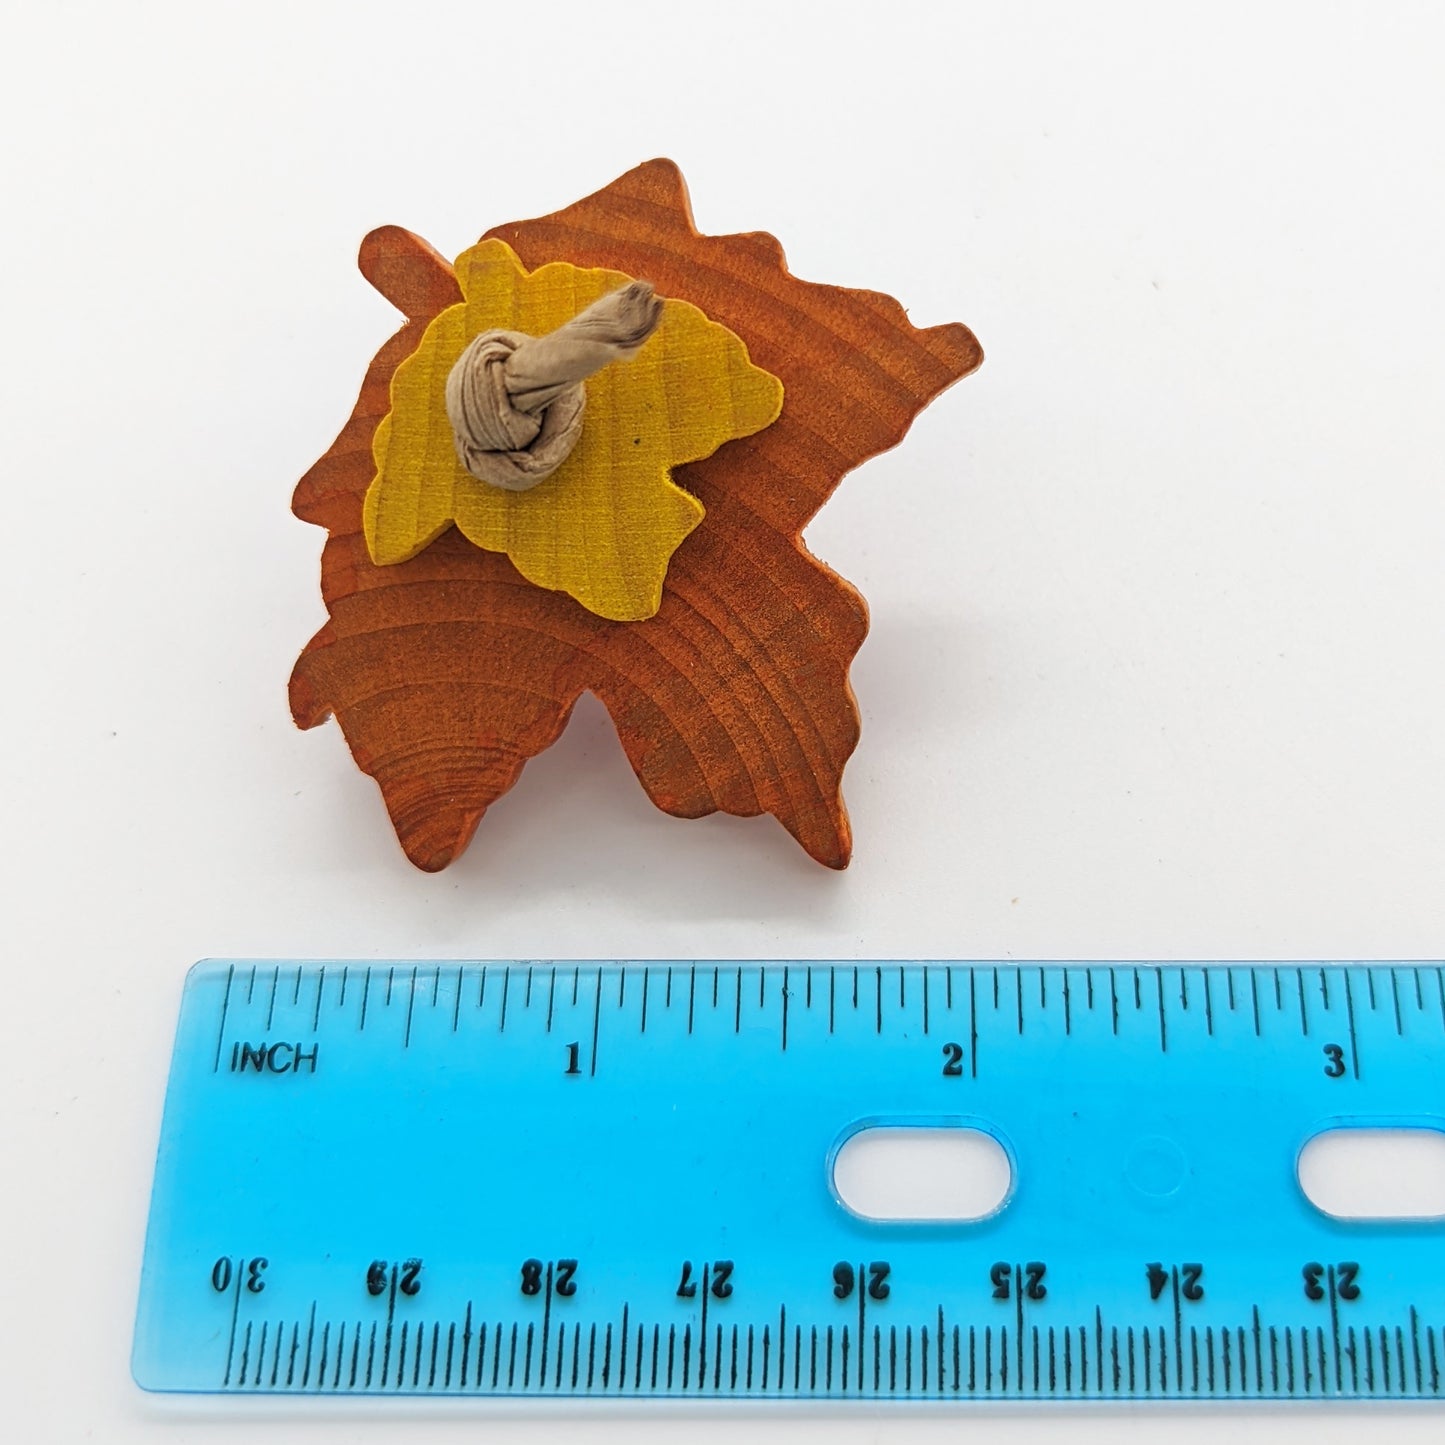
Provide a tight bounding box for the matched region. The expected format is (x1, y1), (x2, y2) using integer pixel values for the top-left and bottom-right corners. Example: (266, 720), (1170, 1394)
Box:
(1299, 1126), (1445, 1222)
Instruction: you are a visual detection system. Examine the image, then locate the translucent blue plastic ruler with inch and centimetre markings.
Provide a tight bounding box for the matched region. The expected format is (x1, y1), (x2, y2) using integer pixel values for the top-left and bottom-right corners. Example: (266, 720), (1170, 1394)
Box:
(133, 961), (1445, 1402)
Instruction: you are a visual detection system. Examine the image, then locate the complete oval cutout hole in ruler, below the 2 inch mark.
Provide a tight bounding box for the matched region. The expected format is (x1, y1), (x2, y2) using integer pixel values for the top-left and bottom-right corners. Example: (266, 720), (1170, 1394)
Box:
(832, 1124), (1013, 1224)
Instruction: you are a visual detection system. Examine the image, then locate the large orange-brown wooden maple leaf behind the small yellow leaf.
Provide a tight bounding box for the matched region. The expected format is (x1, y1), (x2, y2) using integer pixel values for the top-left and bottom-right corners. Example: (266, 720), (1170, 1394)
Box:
(290, 160), (983, 870)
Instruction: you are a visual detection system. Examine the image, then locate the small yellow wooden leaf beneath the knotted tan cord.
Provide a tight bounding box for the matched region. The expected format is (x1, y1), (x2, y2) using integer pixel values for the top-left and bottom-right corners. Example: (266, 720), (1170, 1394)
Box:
(363, 240), (783, 621)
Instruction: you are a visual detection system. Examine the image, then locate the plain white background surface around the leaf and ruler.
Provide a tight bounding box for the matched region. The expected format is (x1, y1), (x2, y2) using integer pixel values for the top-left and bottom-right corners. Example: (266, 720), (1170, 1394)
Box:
(0, 0), (1445, 1445)
